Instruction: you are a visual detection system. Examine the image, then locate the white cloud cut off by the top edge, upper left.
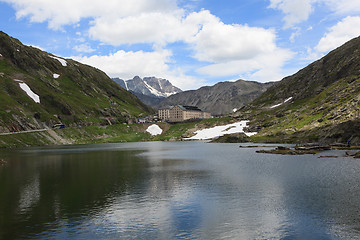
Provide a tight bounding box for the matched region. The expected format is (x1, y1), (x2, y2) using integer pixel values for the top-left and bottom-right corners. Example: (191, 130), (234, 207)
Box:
(2, 0), (176, 29)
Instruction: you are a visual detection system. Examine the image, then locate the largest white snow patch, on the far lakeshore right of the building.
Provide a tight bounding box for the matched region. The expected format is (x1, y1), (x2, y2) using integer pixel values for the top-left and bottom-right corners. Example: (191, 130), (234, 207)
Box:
(185, 121), (257, 140)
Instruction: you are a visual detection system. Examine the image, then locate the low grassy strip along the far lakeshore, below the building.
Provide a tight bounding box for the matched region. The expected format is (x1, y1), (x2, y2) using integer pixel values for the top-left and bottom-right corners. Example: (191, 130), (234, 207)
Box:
(0, 118), (233, 148)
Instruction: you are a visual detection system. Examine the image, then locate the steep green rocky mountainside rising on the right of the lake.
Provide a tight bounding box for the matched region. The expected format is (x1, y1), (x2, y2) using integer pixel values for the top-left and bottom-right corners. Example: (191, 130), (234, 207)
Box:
(235, 34), (360, 144)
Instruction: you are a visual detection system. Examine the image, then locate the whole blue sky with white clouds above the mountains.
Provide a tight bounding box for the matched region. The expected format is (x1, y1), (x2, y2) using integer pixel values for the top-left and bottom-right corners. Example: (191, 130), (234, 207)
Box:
(0, 0), (360, 90)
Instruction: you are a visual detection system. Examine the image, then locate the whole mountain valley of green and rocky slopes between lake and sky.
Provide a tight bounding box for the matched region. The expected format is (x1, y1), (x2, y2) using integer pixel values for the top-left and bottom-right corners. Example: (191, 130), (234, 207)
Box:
(0, 33), (360, 148)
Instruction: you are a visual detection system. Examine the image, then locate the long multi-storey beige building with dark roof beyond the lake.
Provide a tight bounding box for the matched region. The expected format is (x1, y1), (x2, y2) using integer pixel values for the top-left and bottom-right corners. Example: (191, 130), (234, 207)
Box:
(158, 105), (211, 122)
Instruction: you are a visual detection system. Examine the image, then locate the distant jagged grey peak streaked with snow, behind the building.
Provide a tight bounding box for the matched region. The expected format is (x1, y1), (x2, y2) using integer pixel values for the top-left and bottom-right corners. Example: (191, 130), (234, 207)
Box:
(113, 76), (182, 106)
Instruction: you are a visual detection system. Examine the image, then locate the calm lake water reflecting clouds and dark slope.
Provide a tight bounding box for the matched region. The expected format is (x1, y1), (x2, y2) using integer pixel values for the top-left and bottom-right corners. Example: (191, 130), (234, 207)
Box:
(0, 142), (360, 239)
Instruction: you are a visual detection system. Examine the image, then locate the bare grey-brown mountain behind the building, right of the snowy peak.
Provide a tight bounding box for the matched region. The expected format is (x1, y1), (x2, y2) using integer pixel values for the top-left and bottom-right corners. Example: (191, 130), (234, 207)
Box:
(157, 80), (273, 115)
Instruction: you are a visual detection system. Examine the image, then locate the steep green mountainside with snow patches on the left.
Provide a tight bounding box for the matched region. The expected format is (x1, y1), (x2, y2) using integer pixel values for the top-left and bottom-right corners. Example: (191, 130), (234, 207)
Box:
(0, 32), (151, 132)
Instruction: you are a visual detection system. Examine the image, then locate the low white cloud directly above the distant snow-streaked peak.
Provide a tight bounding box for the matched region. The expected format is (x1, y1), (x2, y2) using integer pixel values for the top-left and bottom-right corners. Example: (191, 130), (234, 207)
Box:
(73, 49), (204, 90)
